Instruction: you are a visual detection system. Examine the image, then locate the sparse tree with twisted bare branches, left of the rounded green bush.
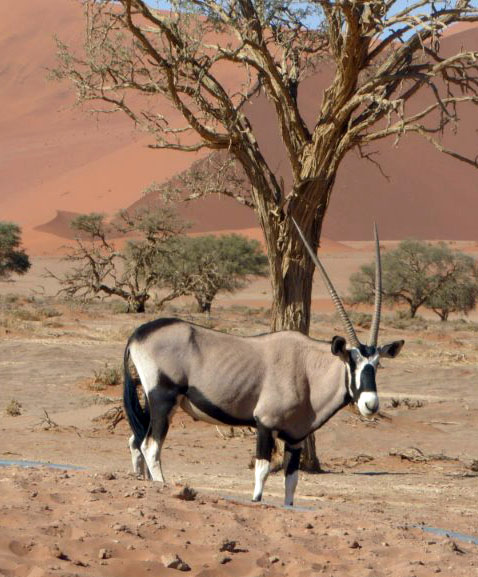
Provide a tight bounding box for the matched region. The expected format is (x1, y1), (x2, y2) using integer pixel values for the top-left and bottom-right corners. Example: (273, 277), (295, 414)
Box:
(47, 208), (185, 313)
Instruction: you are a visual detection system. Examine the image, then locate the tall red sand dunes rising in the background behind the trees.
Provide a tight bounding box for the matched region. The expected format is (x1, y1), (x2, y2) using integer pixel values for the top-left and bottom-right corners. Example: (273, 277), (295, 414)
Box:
(0, 0), (478, 254)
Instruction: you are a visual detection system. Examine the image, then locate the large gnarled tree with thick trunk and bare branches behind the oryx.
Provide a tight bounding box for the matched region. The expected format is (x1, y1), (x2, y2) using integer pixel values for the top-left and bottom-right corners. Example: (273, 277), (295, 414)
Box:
(57, 0), (478, 332)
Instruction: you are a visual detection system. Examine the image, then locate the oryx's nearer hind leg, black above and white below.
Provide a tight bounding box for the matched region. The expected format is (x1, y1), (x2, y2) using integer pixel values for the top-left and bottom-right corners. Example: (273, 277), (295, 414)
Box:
(141, 379), (178, 483)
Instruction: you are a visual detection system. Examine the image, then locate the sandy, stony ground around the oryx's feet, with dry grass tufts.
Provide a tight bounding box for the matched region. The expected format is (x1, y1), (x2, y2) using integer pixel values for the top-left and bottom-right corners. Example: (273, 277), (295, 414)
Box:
(0, 250), (478, 577)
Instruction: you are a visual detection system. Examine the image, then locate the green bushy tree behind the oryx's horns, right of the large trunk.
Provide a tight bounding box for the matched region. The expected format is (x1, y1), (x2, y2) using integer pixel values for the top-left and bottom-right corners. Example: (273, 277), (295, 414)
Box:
(350, 240), (476, 320)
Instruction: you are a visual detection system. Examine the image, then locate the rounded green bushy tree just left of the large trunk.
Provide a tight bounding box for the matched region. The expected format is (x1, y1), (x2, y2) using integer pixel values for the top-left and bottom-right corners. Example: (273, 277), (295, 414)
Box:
(158, 234), (268, 312)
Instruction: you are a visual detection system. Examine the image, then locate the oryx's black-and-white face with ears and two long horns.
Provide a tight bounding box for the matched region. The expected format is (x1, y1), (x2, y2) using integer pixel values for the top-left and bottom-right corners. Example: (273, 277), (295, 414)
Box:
(292, 219), (405, 417)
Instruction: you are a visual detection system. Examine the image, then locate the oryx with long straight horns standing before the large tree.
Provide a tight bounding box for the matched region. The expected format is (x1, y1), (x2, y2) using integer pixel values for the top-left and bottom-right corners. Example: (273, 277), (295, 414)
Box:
(124, 221), (404, 505)
